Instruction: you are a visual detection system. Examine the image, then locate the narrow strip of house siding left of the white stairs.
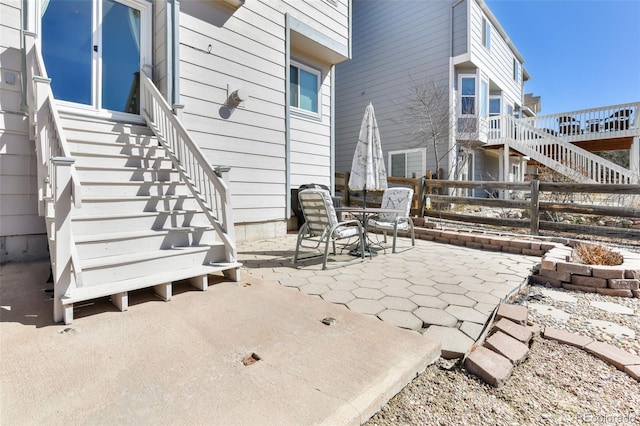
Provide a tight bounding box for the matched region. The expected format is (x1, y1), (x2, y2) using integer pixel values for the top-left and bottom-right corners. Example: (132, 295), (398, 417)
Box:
(0, 0), (46, 248)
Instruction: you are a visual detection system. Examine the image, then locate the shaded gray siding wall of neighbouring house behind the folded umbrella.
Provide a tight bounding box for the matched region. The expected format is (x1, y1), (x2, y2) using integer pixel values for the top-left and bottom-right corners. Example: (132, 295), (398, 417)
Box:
(336, 0), (452, 176)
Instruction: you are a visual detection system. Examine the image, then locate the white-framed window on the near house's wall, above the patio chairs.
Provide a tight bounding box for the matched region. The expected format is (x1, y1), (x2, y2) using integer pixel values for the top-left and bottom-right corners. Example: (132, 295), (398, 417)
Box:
(289, 61), (321, 116)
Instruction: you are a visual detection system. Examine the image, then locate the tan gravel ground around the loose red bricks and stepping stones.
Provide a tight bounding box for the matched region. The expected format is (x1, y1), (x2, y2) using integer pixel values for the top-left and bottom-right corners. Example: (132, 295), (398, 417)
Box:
(367, 286), (640, 426)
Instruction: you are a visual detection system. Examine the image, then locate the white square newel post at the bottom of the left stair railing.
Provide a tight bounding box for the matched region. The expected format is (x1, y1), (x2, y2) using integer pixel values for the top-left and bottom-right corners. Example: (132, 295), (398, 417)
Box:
(51, 157), (75, 323)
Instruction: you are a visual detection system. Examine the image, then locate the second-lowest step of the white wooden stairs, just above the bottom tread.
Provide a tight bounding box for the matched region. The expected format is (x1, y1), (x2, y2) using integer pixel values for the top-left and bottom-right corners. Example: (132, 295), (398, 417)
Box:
(80, 243), (225, 287)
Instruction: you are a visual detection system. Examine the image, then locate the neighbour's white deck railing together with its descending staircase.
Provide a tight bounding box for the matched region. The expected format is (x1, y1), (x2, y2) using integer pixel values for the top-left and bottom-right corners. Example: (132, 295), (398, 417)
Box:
(486, 104), (640, 184)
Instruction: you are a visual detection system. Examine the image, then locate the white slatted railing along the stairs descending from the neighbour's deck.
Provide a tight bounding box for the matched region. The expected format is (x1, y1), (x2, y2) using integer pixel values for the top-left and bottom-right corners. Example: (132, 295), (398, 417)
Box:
(489, 115), (638, 184)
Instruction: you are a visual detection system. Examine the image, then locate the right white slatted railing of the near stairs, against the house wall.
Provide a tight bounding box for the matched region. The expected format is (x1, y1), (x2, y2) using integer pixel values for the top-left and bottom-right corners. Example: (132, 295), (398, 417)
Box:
(140, 73), (237, 262)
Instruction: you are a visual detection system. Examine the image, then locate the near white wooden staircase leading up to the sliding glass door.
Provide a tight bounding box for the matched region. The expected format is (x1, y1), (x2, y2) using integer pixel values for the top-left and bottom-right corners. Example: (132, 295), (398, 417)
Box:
(25, 35), (241, 324)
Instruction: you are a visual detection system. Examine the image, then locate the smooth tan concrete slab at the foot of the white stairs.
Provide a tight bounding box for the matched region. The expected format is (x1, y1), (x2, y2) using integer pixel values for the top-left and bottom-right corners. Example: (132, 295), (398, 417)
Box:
(0, 265), (440, 425)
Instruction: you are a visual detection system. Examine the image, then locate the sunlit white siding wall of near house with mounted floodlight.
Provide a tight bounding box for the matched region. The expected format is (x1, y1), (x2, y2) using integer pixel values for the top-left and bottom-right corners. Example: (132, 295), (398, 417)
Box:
(180, 0), (349, 223)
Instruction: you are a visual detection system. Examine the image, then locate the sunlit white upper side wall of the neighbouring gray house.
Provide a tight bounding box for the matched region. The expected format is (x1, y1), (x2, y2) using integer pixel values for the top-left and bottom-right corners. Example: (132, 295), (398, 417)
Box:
(470, 0), (523, 105)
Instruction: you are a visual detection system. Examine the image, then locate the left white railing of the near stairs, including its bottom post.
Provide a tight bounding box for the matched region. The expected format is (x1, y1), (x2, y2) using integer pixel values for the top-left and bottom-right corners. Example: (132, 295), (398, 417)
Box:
(24, 32), (82, 322)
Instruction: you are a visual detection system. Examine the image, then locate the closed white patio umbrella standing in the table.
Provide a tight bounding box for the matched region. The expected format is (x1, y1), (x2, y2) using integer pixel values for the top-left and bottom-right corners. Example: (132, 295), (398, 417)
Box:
(349, 103), (387, 207)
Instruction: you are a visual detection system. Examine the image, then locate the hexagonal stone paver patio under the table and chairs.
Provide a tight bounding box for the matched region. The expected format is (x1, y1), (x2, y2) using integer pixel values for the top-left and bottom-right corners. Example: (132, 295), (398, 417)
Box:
(238, 234), (540, 356)
